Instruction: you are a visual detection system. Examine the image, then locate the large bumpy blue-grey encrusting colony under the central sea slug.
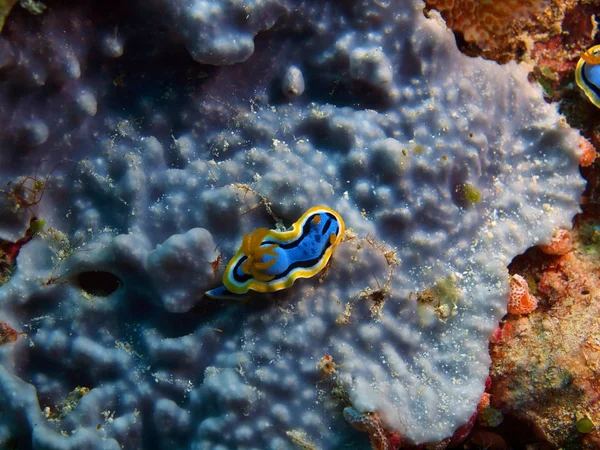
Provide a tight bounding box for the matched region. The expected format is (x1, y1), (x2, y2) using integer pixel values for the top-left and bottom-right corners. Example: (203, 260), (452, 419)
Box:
(0, 0), (591, 450)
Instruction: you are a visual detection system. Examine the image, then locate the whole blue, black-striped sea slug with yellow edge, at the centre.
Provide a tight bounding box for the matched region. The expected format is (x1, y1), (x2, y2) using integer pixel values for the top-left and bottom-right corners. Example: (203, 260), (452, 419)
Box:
(206, 206), (345, 299)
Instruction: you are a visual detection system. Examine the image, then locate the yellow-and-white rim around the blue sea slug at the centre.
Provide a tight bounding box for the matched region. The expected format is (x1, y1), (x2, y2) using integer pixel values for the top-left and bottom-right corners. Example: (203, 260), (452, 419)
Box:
(223, 206), (345, 294)
